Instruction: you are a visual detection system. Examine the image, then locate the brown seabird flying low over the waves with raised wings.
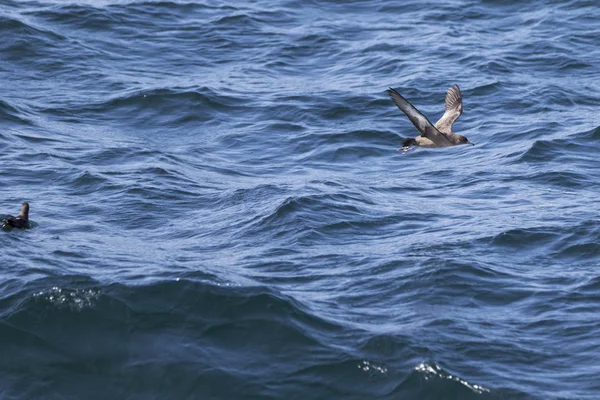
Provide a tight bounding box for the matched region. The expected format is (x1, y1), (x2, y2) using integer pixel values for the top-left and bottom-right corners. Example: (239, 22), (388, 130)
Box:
(387, 85), (474, 148)
